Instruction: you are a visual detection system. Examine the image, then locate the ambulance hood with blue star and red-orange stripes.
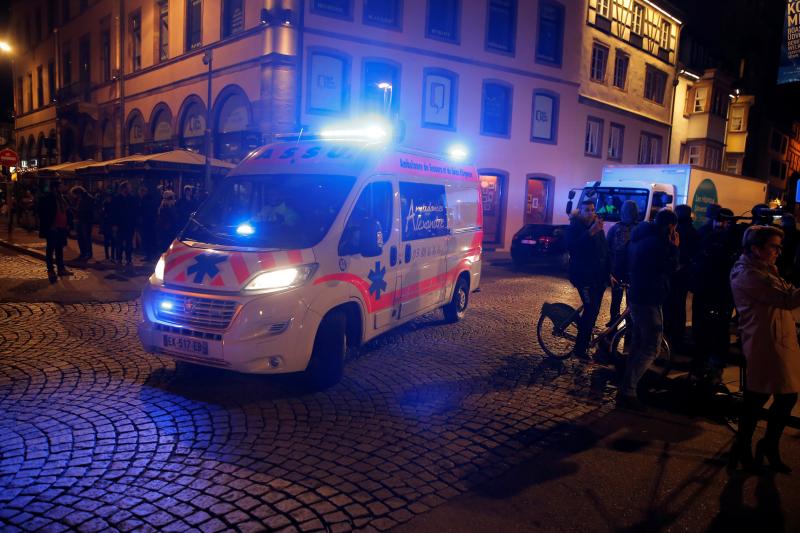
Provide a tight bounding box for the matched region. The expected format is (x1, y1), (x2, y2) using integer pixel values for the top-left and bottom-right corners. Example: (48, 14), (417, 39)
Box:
(164, 240), (315, 292)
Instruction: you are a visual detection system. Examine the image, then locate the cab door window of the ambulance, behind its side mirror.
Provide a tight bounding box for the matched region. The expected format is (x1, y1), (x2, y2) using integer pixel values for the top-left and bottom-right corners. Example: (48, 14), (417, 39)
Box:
(339, 181), (392, 255)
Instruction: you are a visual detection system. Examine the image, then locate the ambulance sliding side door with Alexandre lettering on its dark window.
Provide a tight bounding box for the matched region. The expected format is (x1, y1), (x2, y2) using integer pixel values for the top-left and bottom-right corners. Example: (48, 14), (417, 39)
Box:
(398, 181), (450, 319)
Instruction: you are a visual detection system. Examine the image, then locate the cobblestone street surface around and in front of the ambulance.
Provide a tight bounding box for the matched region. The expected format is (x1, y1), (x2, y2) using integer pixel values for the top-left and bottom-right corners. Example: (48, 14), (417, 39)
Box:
(0, 256), (612, 532)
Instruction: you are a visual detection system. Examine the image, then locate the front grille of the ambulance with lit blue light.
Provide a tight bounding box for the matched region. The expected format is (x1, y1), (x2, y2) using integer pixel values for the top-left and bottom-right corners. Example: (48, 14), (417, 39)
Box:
(156, 293), (236, 329)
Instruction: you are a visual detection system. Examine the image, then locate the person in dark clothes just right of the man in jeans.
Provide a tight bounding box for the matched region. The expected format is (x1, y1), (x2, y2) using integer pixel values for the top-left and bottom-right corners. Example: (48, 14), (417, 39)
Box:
(664, 204), (700, 348)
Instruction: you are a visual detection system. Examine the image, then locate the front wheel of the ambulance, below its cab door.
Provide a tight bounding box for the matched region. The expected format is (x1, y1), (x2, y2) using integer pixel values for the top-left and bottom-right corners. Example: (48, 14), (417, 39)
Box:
(305, 311), (347, 390)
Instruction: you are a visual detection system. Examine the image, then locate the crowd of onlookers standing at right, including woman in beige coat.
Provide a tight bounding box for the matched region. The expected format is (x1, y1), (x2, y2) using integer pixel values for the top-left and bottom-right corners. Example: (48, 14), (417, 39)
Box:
(567, 200), (800, 472)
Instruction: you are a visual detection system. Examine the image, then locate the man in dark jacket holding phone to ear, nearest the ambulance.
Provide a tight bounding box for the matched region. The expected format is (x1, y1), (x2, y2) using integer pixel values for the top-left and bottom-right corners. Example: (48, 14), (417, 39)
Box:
(567, 200), (611, 358)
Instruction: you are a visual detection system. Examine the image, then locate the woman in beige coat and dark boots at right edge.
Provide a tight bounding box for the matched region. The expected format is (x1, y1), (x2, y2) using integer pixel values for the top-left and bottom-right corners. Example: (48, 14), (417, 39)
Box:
(729, 222), (800, 474)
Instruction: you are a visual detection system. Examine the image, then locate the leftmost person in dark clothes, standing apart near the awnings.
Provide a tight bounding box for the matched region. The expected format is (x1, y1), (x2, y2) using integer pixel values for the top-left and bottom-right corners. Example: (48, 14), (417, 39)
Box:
(39, 180), (72, 283)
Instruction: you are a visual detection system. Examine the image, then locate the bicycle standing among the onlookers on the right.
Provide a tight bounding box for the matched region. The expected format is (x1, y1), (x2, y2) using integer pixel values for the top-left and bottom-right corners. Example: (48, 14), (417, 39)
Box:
(536, 284), (672, 376)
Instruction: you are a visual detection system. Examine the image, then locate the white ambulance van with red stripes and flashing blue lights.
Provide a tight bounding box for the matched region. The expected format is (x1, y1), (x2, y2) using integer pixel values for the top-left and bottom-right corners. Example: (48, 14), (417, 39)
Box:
(138, 132), (483, 387)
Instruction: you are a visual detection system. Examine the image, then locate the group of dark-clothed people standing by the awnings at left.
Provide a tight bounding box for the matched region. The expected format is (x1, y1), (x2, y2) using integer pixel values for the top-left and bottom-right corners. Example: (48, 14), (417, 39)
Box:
(26, 180), (199, 283)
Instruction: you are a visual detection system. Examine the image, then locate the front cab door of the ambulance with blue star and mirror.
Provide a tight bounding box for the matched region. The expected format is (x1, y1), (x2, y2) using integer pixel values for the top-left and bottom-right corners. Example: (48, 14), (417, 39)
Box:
(339, 181), (398, 330)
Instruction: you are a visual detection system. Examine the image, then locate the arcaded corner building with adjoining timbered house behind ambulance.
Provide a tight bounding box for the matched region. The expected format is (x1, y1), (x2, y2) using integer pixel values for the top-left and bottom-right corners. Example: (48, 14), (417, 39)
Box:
(12, 0), (681, 249)
